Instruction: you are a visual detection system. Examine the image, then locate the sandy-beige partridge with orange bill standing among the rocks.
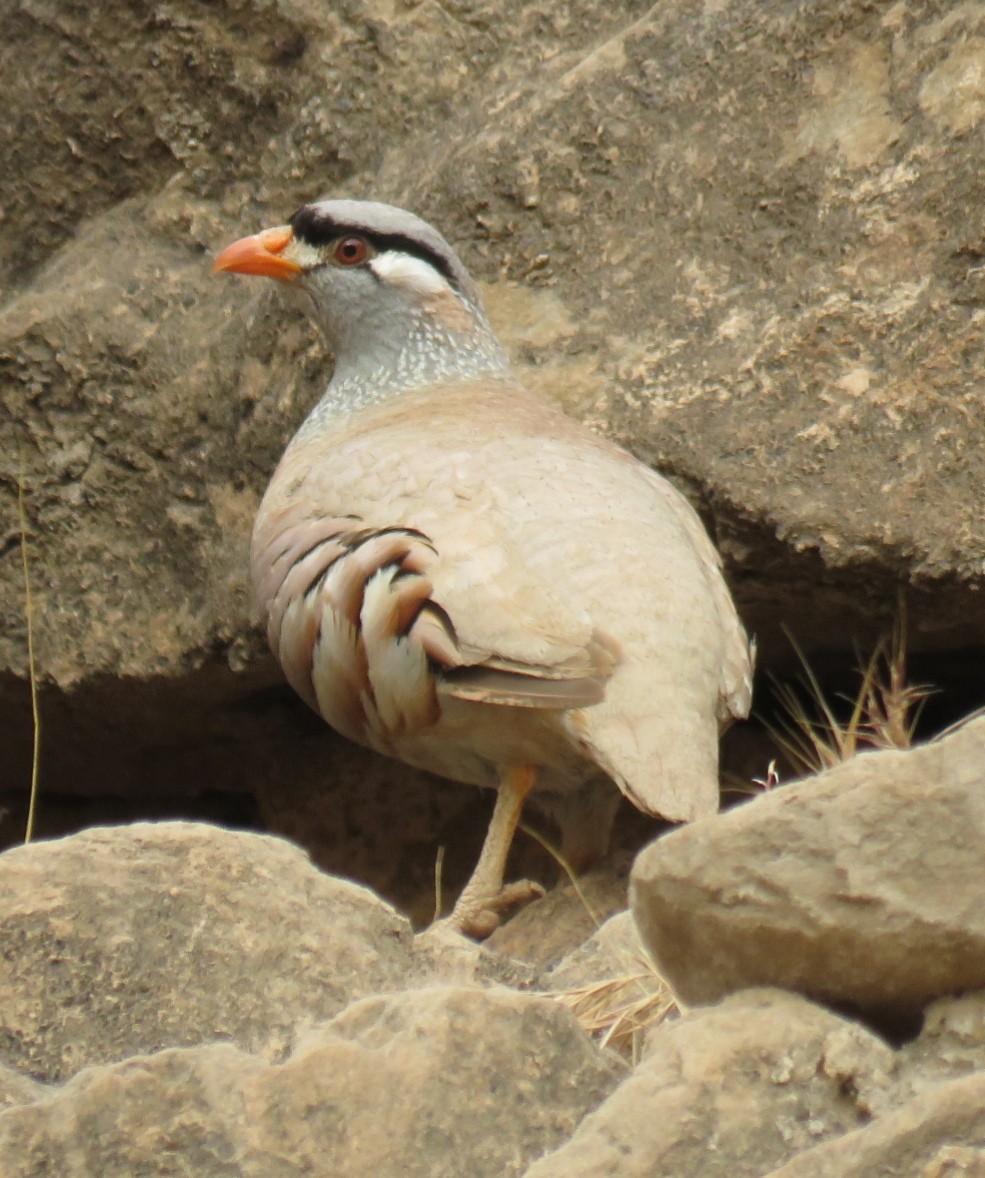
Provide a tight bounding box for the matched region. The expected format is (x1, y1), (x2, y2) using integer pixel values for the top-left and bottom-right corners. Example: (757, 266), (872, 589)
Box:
(212, 199), (753, 939)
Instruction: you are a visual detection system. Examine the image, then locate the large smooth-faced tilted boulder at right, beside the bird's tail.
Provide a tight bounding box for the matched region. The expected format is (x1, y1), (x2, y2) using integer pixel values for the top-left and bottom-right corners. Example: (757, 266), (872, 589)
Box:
(632, 719), (985, 1024)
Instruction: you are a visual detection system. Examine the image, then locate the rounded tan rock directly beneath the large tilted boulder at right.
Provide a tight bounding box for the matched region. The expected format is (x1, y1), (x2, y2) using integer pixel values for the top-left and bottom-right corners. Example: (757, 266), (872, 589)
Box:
(525, 991), (893, 1178)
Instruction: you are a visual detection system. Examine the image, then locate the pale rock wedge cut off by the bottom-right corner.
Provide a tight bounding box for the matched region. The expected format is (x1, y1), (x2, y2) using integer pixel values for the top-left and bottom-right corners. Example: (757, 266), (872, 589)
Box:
(766, 1073), (985, 1178)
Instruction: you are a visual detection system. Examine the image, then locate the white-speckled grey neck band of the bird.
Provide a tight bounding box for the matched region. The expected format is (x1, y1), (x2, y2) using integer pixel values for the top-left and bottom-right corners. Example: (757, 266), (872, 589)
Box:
(298, 312), (509, 437)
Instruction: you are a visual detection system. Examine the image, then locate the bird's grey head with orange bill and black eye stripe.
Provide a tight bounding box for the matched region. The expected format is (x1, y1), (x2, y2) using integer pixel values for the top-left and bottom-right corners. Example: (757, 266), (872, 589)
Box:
(212, 200), (505, 379)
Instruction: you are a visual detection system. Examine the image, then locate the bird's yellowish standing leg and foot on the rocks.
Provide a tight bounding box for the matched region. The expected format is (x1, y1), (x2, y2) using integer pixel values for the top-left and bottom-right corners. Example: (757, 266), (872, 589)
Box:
(448, 765), (543, 938)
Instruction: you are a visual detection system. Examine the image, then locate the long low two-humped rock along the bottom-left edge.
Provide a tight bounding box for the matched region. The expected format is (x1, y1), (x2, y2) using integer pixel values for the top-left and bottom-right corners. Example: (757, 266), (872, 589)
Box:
(0, 988), (622, 1178)
